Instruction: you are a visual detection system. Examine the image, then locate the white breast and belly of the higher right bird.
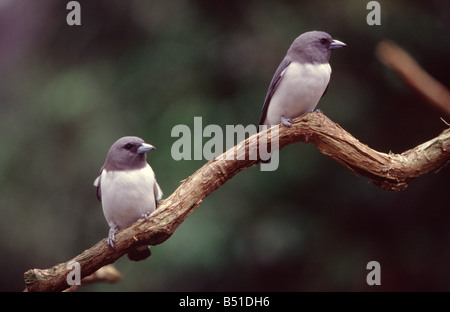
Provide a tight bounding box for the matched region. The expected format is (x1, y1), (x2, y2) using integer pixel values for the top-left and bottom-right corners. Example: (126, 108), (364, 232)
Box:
(266, 62), (331, 125)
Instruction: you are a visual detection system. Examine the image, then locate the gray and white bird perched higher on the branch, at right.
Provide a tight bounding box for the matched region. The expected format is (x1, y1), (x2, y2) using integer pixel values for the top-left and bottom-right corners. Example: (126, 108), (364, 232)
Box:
(259, 31), (346, 127)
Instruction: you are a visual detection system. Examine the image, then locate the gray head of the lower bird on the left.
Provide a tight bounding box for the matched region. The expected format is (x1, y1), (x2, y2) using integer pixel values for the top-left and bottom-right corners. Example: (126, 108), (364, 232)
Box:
(103, 136), (155, 170)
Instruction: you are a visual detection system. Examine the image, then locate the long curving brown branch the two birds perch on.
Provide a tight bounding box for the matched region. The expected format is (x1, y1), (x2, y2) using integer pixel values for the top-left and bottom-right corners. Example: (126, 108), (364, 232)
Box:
(25, 113), (450, 291)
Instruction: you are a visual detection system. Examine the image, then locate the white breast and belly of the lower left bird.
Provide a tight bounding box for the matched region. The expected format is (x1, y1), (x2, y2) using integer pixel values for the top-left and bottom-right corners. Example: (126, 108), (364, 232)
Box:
(100, 164), (160, 229)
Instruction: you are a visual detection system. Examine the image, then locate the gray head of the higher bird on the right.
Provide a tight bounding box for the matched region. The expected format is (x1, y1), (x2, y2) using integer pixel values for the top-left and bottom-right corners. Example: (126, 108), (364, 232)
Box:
(288, 31), (347, 64)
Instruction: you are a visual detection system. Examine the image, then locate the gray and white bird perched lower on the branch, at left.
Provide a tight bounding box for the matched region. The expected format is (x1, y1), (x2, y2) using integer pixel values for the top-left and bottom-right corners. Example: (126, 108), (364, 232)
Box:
(94, 136), (162, 261)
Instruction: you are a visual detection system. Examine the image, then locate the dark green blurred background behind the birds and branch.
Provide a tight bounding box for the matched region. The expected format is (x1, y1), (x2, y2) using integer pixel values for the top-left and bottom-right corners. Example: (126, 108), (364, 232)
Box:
(0, 0), (450, 291)
